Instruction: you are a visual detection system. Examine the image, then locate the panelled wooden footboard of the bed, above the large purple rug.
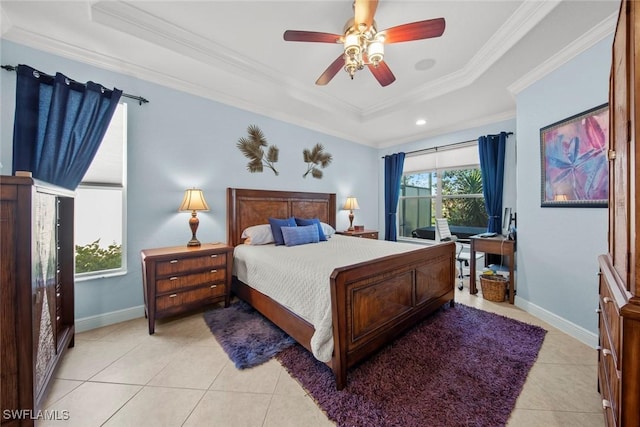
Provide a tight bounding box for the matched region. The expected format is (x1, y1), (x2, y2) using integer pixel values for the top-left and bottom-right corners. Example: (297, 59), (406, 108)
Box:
(331, 243), (455, 390)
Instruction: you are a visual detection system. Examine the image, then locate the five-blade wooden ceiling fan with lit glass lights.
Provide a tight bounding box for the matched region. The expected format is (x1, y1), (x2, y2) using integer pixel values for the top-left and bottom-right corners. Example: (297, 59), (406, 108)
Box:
(284, 0), (445, 86)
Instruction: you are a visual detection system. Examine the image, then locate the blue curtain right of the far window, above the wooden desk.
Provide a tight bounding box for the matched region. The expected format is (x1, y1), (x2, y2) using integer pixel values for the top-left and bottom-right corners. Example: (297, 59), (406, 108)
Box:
(478, 132), (507, 234)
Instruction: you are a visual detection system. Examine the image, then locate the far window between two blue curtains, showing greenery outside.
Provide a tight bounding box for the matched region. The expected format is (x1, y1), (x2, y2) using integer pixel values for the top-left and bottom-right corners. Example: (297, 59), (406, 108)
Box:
(398, 142), (488, 239)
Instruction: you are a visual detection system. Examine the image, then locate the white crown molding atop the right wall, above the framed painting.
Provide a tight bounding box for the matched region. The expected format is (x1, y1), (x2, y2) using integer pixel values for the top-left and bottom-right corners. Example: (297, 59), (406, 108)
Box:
(507, 13), (618, 96)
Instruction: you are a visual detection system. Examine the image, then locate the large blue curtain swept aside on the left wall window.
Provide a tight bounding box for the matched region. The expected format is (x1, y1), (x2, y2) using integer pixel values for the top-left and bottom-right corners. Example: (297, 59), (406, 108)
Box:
(13, 65), (122, 190)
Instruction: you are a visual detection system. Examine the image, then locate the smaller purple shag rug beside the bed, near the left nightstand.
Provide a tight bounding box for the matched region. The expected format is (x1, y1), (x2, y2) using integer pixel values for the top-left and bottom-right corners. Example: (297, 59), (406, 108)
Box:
(204, 301), (295, 369)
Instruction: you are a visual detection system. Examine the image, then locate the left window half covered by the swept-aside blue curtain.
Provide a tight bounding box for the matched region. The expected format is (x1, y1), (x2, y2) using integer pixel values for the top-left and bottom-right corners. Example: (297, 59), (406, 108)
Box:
(75, 103), (127, 280)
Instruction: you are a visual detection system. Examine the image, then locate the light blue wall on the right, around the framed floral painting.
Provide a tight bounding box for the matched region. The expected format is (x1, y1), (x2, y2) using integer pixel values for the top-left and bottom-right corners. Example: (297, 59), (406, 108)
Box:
(516, 37), (613, 334)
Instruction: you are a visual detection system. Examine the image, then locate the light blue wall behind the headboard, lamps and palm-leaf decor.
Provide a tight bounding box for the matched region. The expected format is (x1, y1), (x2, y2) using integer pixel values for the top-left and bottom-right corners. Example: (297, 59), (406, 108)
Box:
(0, 40), (378, 319)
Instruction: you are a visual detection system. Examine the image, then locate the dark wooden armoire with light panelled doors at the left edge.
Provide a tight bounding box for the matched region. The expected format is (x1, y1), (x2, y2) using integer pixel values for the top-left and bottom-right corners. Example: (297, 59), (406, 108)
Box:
(0, 176), (75, 427)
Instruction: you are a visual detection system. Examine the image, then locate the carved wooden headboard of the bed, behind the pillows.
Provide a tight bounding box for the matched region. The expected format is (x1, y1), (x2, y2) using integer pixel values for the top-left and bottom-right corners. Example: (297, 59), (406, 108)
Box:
(227, 188), (336, 247)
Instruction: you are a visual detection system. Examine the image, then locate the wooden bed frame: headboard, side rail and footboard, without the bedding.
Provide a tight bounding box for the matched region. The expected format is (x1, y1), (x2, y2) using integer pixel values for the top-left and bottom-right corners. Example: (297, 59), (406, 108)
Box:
(227, 188), (455, 390)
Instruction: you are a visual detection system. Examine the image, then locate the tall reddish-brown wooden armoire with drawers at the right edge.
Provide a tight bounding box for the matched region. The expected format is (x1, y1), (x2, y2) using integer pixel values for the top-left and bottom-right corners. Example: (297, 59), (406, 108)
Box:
(598, 0), (640, 427)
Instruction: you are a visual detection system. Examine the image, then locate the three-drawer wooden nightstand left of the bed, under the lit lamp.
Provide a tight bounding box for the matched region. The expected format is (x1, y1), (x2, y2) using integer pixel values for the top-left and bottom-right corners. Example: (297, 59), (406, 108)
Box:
(140, 243), (233, 335)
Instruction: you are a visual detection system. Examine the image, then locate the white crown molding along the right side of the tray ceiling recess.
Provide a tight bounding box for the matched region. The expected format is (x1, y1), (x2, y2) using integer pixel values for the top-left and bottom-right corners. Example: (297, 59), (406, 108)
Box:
(363, 0), (560, 120)
